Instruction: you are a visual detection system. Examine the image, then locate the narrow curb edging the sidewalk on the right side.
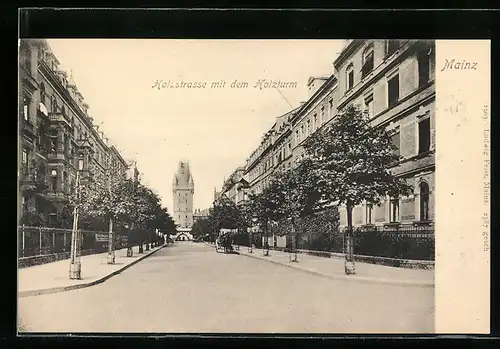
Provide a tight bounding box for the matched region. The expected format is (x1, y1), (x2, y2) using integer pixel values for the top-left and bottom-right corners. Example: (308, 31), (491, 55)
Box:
(240, 253), (435, 288)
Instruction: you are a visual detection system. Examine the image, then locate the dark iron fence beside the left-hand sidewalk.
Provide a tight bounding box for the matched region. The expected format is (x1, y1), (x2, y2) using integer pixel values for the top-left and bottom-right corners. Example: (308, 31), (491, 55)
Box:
(17, 226), (127, 258)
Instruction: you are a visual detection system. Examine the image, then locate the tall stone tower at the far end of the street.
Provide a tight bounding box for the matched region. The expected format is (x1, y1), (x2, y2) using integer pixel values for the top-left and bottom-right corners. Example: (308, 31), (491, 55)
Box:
(172, 161), (194, 228)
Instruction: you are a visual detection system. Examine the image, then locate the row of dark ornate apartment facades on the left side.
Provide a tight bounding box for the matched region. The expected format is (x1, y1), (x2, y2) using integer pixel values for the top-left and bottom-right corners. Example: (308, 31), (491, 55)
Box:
(18, 39), (128, 223)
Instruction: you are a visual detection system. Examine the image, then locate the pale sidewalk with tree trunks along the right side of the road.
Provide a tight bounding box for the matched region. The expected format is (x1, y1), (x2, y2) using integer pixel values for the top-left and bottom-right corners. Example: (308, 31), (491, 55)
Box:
(237, 246), (434, 287)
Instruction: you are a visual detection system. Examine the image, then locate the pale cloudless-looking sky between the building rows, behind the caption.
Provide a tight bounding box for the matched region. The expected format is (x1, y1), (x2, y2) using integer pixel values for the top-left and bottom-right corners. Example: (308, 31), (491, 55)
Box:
(48, 39), (343, 212)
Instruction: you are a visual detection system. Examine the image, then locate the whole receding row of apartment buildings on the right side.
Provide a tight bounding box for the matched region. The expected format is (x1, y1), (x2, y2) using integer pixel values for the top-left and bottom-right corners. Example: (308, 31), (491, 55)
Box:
(218, 40), (435, 247)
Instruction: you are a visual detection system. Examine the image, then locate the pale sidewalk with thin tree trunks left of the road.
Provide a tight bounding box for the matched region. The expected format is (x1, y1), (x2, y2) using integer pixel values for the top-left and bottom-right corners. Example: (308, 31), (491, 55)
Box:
(17, 245), (166, 297)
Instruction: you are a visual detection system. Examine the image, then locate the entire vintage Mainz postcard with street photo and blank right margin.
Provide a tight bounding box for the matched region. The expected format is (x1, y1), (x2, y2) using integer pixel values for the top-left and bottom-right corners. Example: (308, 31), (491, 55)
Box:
(17, 38), (490, 335)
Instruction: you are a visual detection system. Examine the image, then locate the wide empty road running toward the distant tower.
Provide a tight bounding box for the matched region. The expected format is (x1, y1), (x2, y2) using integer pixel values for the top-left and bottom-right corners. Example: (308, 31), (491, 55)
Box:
(18, 242), (434, 333)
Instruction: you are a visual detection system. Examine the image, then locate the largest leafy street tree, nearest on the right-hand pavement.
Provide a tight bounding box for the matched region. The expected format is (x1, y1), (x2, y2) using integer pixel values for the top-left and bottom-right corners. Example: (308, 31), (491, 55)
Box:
(305, 105), (411, 274)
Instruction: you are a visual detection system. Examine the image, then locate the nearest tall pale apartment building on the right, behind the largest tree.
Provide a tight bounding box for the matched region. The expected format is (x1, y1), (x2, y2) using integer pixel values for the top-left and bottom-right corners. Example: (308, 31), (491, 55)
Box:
(334, 40), (435, 225)
